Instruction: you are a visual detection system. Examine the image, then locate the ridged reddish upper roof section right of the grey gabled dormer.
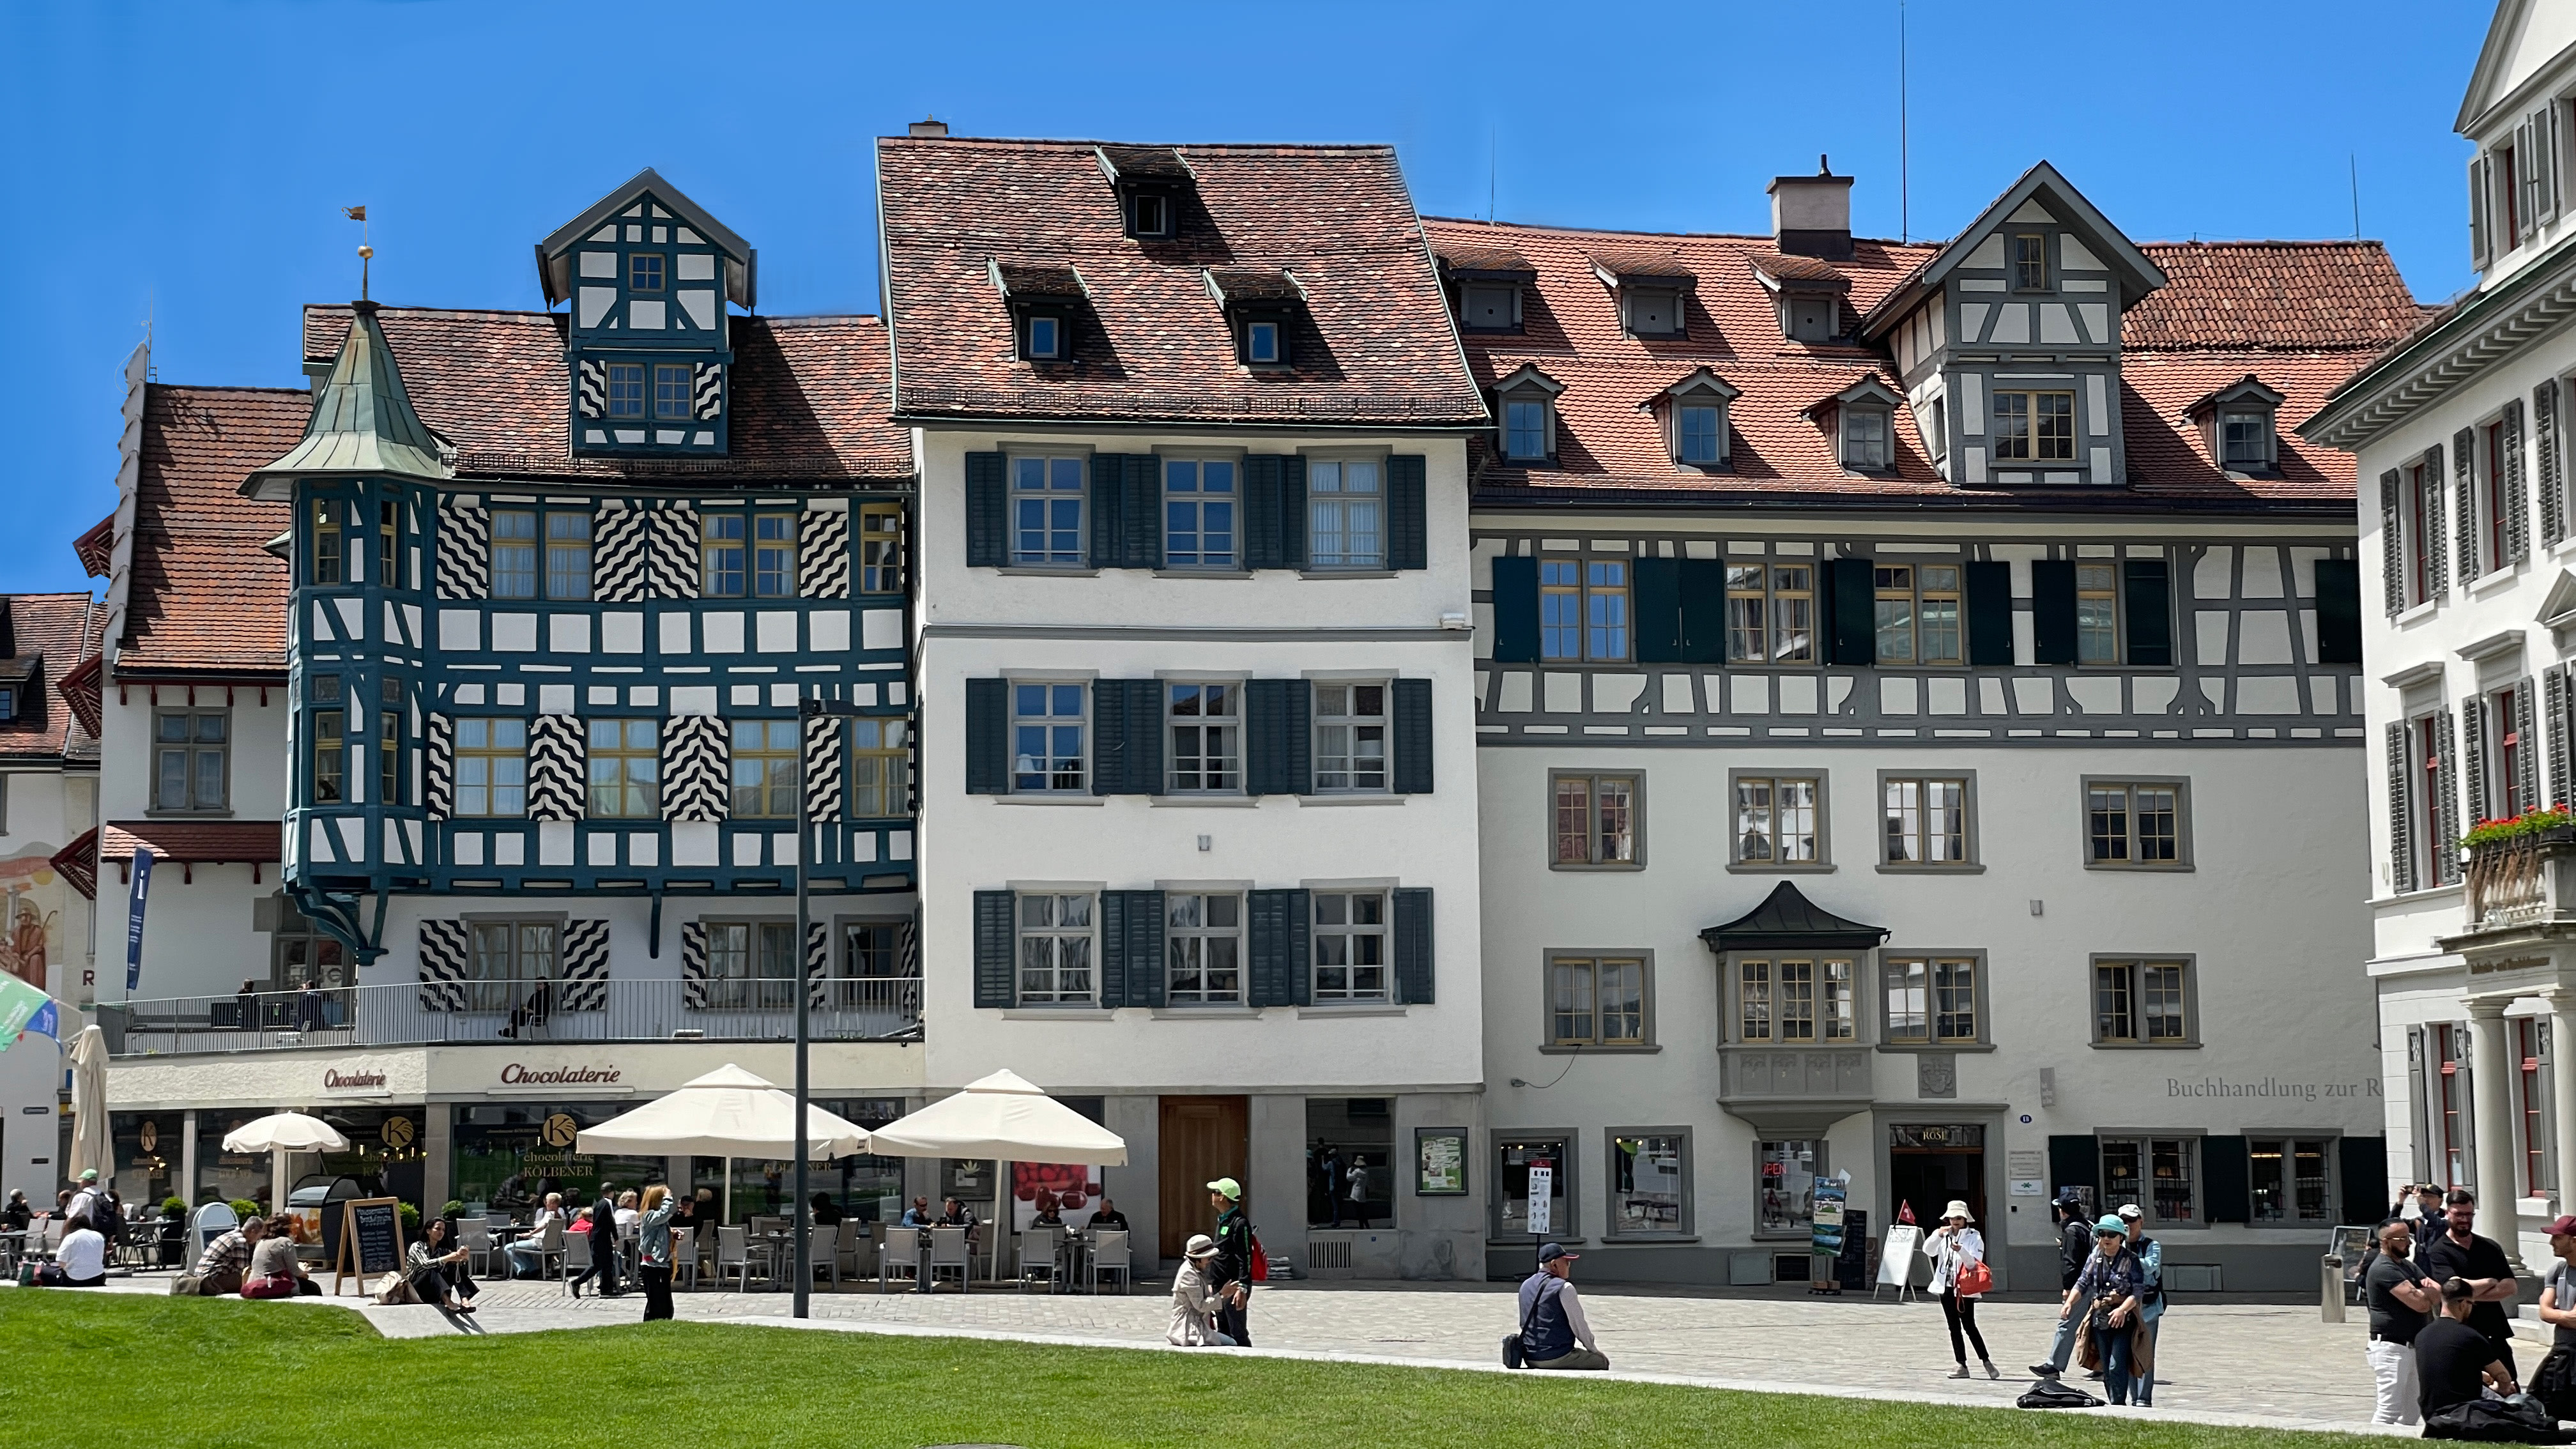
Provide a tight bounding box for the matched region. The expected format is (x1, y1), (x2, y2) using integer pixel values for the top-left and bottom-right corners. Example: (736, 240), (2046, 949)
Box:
(2120, 242), (2424, 353)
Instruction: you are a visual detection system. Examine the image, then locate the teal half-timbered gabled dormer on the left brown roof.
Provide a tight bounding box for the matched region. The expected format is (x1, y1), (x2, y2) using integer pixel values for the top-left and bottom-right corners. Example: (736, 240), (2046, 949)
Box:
(536, 167), (760, 456)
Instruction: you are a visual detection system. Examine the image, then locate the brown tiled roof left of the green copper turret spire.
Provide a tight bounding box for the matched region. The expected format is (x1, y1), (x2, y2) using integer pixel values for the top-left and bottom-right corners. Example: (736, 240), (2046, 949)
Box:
(116, 384), (312, 675)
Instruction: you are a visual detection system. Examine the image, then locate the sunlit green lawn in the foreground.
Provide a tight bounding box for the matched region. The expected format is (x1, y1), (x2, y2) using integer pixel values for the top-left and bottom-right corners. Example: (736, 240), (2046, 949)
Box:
(0, 1292), (2357, 1449)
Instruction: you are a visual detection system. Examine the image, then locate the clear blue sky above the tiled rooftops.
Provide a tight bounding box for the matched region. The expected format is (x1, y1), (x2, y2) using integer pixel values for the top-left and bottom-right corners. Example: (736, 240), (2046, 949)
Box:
(0, 0), (2488, 590)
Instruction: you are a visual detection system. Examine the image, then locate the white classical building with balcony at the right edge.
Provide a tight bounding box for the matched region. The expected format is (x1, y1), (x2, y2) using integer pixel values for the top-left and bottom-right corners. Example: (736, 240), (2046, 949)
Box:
(2303, 0), (2576, 1263)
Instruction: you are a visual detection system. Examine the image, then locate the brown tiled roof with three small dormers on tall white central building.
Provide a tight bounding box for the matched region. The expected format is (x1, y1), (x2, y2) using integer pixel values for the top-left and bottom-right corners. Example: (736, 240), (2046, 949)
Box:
(878, 137), (1483, 428)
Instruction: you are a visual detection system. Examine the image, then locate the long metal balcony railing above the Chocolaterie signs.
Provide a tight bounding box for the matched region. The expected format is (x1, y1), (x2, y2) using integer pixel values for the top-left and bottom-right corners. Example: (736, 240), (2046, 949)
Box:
(100, 977), (922, 1057)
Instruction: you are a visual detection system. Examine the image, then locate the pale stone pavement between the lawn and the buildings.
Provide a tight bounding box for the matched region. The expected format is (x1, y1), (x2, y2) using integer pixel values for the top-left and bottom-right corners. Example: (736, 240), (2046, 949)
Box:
(30, 1274), (2432, 1434)
